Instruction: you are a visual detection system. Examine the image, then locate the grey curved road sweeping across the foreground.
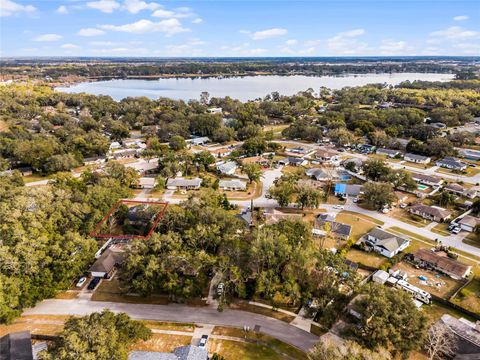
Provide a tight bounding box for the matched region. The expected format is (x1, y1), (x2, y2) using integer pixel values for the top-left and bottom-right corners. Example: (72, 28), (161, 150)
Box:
(23, 299), (318, 351)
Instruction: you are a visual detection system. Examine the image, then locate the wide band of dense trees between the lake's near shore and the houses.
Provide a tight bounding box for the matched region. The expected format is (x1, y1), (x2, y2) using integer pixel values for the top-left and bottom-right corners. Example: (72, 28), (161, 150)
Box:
(0, 80), (480, 173)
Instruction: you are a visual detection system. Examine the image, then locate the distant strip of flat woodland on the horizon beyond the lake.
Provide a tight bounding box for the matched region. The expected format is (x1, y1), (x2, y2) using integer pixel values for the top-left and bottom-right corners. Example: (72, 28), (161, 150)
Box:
(2, 58), (475, 79)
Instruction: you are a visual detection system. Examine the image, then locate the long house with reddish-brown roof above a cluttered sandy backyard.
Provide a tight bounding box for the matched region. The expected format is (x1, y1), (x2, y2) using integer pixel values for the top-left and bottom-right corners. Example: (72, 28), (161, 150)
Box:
(413, 249), (472, 280)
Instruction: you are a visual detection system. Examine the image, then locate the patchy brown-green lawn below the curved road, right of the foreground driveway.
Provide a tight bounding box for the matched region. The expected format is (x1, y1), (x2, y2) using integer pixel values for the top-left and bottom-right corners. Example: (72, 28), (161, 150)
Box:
(212, 326), (305, 359)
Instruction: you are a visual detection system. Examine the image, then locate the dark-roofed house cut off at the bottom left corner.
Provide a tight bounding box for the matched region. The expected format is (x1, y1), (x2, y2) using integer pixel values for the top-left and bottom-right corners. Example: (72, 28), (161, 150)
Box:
(0, 331), (33, 360)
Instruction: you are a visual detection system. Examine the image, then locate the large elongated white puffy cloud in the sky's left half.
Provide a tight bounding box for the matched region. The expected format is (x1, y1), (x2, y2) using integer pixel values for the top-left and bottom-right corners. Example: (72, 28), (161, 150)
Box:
(101, 18), (190, 36)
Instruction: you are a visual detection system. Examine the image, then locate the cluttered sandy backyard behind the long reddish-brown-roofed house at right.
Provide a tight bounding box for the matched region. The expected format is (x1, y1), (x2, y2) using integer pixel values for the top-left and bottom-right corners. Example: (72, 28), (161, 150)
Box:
(393, 262), (462, 300)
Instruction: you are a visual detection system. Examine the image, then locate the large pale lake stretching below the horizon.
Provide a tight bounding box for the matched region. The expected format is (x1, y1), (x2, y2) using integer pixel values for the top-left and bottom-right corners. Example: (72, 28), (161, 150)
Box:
(57, 73), (454, 101)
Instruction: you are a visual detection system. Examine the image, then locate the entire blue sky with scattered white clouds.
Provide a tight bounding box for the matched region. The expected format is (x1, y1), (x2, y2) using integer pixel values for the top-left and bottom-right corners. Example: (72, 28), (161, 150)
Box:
(0, 0), (480, 57)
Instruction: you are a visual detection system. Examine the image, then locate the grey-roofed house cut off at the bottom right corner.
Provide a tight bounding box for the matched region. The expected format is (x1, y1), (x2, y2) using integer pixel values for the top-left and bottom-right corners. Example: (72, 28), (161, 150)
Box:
(438, 314), (480, 360)
